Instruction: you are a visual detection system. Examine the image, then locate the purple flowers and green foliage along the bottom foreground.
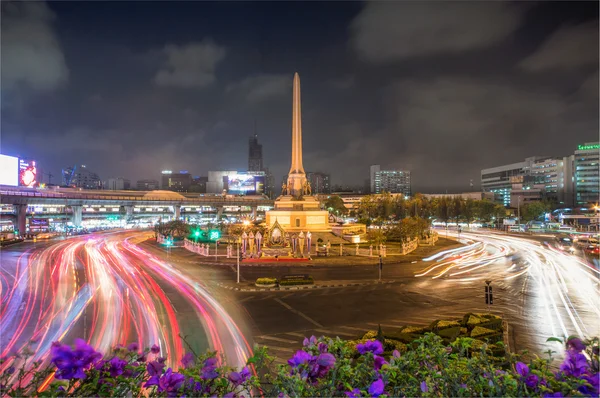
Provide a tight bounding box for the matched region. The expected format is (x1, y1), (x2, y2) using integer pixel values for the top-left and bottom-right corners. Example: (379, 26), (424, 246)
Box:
(0, 333), (599, 398)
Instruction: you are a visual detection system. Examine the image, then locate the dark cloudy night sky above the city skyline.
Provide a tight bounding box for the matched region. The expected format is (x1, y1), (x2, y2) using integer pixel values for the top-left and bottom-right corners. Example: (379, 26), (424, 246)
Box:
(0, 1), (599, 191)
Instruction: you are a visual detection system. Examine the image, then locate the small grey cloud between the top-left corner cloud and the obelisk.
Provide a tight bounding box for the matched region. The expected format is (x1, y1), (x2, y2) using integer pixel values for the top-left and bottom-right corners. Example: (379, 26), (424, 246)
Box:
(154, 40), (226, 88)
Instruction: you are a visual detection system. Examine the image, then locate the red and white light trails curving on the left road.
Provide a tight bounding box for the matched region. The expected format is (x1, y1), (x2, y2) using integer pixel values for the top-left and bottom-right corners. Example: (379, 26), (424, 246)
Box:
(0, 233), (252, 386)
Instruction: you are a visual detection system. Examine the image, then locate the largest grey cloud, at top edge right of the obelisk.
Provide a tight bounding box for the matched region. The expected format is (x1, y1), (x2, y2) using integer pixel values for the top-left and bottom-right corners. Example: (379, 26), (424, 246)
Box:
(351, 1), (524, 63)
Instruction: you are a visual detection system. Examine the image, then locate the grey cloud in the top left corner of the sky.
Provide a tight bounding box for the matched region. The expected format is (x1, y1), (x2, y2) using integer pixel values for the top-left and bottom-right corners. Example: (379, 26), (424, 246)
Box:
(1, 2), (69, 91)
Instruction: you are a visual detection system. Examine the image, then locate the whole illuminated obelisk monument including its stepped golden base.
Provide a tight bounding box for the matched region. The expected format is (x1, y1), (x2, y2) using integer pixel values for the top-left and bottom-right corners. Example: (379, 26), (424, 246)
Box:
(266, 73), (331, 232)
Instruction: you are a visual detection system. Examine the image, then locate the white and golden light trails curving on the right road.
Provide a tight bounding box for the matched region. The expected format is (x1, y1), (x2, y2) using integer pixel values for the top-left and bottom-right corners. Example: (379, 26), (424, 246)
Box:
(415, 232), (600, 338)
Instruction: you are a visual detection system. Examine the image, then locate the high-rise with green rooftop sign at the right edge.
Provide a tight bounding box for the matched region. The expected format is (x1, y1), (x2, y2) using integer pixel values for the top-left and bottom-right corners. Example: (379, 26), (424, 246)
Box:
(573, 142), (600, 204)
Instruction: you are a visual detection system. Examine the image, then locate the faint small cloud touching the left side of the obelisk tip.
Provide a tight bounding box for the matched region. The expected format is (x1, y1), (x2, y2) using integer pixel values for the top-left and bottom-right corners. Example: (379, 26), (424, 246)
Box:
(227, 74), (293, 103)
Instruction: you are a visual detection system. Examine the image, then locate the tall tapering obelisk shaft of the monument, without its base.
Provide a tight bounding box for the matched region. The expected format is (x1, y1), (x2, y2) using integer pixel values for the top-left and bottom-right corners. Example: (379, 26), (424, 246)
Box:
(288, 72), (306, 196)
